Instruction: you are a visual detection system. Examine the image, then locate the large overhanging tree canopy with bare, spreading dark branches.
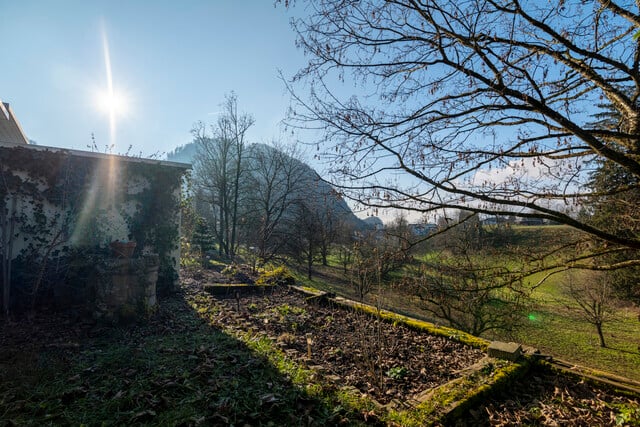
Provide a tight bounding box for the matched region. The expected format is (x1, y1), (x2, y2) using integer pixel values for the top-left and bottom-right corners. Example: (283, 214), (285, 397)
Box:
(289, 0), (640, 268)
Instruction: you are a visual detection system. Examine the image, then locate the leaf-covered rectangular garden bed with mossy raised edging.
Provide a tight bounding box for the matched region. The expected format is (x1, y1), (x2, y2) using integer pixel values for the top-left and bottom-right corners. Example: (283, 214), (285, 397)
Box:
(205, 287), (484, 404)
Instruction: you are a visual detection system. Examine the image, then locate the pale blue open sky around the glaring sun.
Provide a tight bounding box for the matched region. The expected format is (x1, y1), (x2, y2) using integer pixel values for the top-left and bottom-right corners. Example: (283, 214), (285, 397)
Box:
(0, 0), (305, 157)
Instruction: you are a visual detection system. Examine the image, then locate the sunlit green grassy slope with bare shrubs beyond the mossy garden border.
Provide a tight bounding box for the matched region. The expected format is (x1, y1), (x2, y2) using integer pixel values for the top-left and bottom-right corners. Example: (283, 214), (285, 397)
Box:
(298, 224), (640, 380)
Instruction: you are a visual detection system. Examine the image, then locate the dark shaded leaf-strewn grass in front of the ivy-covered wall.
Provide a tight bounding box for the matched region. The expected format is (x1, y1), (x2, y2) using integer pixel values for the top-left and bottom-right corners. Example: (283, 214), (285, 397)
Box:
(0, 295), (356, 426)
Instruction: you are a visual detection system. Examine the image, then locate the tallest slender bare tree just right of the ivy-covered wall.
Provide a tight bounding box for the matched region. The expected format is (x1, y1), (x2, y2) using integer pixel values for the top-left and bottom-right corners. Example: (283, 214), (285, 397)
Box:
(192, 92), (254, 258)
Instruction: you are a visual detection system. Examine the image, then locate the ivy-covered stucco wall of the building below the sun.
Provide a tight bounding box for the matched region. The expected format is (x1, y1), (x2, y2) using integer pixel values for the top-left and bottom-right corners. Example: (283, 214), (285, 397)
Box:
(0, 145), (187, 310)
